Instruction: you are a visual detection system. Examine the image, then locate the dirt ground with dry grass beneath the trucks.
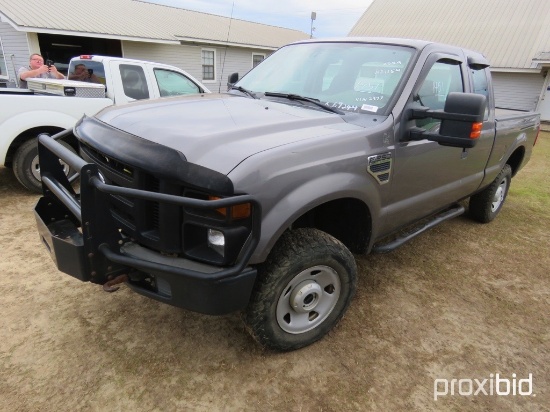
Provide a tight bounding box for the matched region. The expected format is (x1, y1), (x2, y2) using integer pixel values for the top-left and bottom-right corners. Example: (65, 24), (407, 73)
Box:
(0, 133), (550, 411)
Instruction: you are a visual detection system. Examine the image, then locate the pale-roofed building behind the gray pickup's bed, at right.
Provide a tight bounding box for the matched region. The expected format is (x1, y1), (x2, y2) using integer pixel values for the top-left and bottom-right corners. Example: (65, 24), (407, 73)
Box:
(349, 0), (550, 120)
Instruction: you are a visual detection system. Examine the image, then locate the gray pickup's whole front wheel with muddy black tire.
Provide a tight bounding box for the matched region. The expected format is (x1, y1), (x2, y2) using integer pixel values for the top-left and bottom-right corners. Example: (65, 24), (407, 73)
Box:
(244, 229), (357, 351)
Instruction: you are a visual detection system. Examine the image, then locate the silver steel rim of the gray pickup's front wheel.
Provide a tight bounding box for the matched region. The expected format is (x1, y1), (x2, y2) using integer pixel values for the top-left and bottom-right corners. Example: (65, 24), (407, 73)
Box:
(277, 265), (342, 334)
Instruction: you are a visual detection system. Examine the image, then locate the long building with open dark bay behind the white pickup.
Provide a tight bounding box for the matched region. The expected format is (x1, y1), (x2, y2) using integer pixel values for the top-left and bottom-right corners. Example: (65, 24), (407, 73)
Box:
(0, 0), (309, 91)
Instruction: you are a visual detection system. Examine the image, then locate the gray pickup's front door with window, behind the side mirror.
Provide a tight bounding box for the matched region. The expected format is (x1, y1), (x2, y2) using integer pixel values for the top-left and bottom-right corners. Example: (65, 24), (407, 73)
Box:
(386, 53), (494, 231)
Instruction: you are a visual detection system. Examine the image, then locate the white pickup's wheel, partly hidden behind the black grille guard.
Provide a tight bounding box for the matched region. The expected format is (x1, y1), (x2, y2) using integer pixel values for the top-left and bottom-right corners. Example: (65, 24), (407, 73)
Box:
(13, 139), (76, 193)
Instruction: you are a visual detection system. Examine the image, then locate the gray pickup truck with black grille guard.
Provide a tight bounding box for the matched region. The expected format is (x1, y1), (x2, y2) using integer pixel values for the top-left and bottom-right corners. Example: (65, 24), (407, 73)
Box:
(35, 38), (540, 351)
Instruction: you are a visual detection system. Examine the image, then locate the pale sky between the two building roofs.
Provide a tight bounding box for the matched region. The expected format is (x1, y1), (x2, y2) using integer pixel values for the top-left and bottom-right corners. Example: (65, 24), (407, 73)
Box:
(147, 0), (373, 38)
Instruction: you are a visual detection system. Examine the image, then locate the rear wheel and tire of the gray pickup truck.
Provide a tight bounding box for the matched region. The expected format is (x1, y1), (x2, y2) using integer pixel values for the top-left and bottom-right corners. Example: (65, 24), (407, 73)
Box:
(468, 165), (512, 223)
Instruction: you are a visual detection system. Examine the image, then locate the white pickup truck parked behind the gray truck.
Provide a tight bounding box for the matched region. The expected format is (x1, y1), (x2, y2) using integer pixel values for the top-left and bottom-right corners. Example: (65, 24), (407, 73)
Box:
(0, 56), (210, 192)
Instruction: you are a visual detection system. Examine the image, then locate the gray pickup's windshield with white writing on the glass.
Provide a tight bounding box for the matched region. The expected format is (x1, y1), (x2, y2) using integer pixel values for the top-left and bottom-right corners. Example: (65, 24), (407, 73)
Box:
(237, 43), (414, 114)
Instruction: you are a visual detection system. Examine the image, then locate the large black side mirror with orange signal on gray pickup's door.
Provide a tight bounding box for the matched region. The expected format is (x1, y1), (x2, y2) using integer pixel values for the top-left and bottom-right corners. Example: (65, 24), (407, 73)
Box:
(409, 92), (487, 148)
